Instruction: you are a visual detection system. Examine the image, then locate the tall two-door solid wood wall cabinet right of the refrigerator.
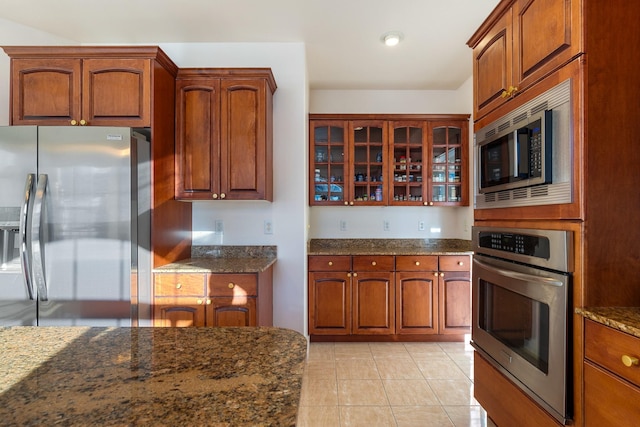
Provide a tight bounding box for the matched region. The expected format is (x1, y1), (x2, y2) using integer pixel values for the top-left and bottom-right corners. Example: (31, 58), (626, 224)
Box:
(175, 68), (276, 201)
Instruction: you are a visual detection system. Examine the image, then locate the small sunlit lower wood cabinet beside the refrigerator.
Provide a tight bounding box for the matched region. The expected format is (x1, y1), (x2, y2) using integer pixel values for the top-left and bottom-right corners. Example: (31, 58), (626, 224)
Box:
(153, 268), (273, 327)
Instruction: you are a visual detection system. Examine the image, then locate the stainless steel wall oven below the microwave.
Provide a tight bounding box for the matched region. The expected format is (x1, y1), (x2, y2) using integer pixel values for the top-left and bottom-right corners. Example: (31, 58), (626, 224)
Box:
(472, 227), (573, 423)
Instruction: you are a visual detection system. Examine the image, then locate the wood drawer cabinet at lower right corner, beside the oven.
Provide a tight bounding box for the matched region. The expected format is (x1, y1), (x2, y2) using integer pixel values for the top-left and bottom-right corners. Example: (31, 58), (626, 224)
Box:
(584, 320), (640, 427)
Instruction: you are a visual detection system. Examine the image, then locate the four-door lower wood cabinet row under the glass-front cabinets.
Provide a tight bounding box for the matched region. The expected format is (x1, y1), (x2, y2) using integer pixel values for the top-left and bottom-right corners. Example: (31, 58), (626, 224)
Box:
(308, 255), (471, 340)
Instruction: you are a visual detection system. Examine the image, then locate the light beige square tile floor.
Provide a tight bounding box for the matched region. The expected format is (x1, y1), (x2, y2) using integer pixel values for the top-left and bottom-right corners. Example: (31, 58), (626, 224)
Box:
(297, 342), (492, 427)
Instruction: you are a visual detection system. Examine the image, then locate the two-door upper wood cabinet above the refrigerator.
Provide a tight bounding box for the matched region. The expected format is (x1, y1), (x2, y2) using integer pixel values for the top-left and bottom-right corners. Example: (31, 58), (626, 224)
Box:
(4, 46), (168, 127)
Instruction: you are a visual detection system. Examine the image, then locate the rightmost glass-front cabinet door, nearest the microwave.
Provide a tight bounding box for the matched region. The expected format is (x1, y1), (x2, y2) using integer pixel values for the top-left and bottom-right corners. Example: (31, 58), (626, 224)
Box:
(429, 122), (469, 205)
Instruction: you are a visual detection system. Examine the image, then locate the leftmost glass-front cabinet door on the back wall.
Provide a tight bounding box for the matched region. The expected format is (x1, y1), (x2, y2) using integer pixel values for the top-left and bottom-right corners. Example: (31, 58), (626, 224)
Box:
(309, 121), (352, 205)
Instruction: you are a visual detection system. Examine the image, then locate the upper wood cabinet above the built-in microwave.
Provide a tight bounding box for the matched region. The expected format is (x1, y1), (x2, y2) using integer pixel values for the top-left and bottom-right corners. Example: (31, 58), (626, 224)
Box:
(467, 0), (584, 120)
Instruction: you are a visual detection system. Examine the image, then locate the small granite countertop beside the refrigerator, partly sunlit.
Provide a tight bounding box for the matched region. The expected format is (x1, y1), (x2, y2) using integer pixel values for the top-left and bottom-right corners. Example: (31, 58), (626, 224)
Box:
(153, 245), (277, 273)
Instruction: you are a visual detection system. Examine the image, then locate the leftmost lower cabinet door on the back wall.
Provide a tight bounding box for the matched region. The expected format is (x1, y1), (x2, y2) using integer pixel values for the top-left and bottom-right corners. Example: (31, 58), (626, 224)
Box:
(309, 271), (351, 335)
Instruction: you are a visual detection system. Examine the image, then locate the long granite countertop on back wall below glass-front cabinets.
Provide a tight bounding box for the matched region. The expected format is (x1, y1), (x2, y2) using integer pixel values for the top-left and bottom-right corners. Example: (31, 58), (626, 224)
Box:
(308, 239), (473, 255)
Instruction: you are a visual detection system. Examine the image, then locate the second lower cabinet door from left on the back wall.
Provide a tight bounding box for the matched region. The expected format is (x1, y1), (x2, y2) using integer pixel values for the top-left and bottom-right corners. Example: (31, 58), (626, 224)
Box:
(353, 273), (395, 335)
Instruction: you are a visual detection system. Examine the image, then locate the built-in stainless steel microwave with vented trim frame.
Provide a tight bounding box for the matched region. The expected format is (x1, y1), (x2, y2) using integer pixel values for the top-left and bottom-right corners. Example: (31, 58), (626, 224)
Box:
(474, 80), (573, 209)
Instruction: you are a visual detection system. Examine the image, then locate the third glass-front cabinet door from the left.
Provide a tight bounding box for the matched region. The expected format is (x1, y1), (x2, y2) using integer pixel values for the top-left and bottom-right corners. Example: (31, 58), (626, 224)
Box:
(389, 121), (428, 205)
